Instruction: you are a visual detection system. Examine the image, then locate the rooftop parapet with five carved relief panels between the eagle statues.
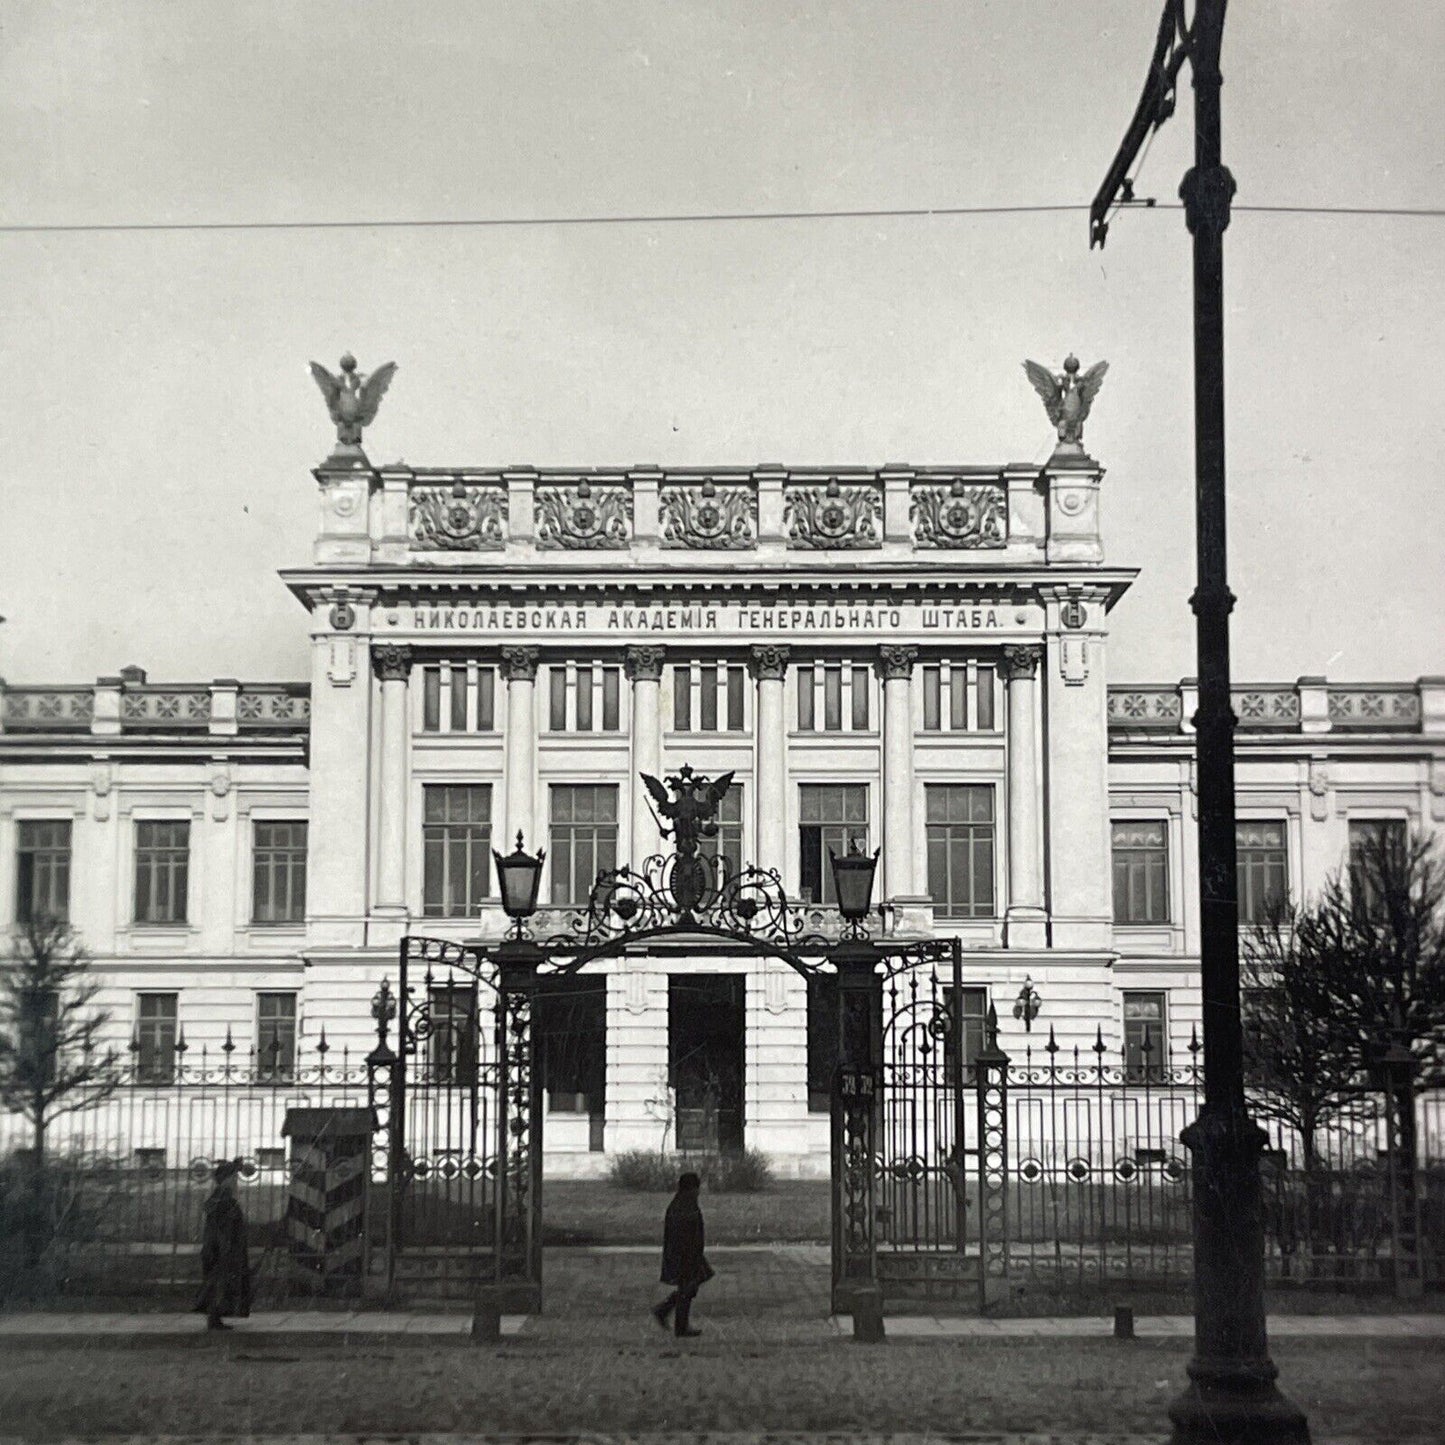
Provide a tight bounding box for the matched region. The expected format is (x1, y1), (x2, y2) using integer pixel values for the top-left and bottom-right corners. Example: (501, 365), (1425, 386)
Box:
(316, 462), (1103, 565)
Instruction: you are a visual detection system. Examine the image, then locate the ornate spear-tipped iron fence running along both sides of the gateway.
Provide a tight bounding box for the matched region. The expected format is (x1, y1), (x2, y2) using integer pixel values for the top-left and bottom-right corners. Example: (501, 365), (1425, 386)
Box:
(0, 1028), (1445, 1298)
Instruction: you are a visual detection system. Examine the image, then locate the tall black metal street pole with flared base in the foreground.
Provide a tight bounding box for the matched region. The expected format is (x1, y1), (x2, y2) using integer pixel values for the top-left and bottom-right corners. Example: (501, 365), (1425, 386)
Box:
(1169, 0), (1309, 1445)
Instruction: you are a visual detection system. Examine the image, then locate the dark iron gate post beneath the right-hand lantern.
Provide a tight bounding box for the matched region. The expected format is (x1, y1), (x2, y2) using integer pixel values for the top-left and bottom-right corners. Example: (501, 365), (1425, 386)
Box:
(832, 942), (883, 1315)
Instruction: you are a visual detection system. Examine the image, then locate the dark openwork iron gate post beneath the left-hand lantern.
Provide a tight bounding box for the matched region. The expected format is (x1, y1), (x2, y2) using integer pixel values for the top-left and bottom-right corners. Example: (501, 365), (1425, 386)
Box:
(493, 939), (542, 1315)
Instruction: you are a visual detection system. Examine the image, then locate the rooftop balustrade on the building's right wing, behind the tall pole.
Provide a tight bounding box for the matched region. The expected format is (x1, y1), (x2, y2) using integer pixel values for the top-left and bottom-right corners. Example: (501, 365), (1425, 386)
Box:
(1108, 678), (1445, 734)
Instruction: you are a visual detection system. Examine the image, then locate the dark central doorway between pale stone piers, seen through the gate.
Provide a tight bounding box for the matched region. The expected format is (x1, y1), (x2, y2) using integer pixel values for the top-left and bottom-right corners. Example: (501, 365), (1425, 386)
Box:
(668, 974), (747, 1153)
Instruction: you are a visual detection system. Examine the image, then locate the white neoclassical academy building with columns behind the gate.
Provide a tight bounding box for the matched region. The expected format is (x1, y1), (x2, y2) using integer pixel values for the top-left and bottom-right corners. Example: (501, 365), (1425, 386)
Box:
(0, 404), (1445, 1173)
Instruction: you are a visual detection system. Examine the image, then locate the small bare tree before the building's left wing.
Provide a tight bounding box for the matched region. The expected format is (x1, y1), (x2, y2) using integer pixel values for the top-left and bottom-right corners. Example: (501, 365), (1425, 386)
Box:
(0, 918), (120, 1178)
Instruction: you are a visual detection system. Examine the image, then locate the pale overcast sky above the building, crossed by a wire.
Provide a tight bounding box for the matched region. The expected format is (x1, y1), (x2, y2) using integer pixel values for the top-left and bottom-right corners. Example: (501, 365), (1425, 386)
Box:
(0, 0), (1445, 682)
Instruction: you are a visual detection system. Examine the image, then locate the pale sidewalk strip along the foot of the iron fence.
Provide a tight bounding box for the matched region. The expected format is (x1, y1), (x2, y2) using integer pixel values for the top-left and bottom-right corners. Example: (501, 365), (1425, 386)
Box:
(0, 1311), (1445, 1341)
